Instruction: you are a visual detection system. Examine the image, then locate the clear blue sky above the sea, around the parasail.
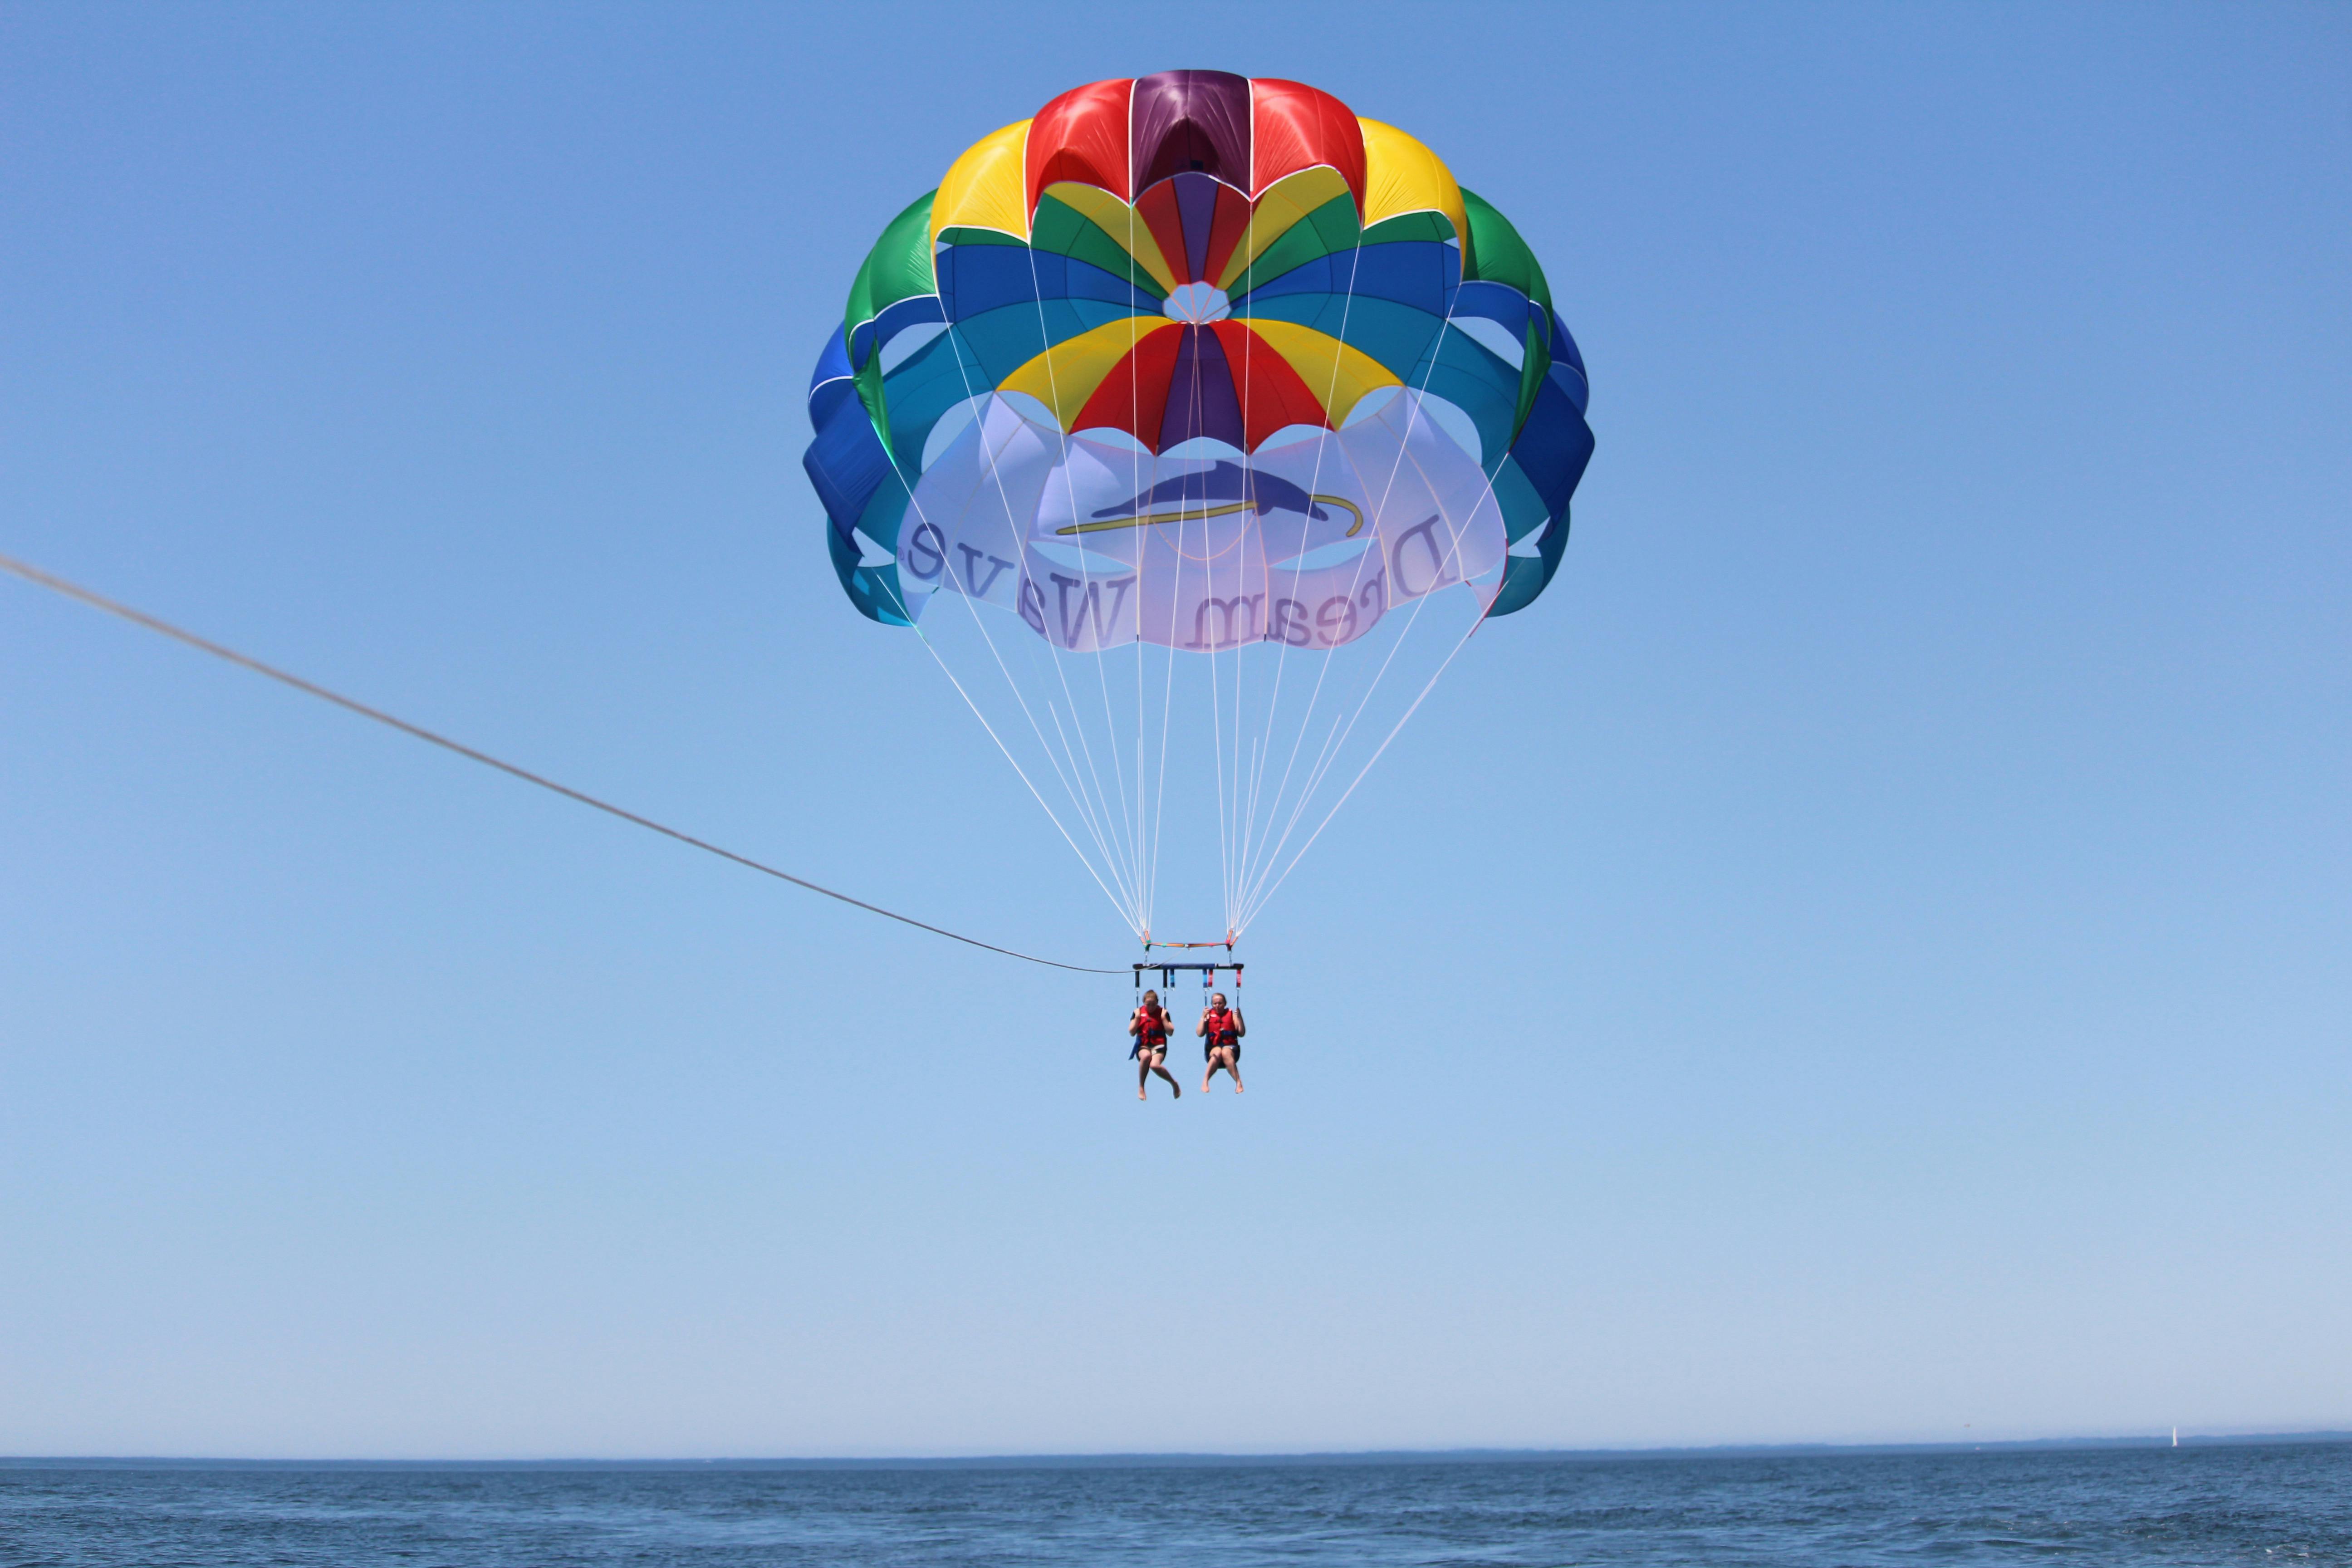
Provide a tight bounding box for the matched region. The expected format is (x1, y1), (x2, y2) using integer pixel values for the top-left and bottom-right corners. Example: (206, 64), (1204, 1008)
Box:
(0, 5), (2352, 1455)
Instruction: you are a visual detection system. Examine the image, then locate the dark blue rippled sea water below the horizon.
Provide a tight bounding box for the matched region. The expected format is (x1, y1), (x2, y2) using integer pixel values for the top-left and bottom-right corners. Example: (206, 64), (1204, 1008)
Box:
(0, 1441), (2352, 1568)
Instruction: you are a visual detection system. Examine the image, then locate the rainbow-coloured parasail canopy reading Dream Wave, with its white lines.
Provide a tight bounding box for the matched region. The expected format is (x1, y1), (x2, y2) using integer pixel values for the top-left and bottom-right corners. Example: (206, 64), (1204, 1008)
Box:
(807, 70), (1592, 933)
